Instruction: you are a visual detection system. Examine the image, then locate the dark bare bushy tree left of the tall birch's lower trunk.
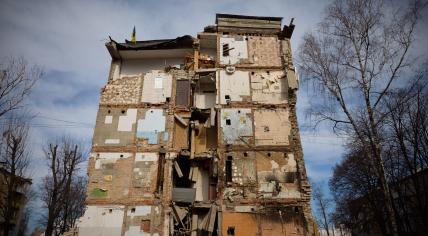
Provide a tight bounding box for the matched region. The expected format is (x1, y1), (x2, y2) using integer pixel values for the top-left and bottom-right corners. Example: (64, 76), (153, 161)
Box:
(329, 147), (387, 235)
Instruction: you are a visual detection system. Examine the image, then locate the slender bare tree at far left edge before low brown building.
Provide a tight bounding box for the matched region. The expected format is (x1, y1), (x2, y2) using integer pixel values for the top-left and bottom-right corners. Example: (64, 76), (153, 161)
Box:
(0, 118), (31, 235)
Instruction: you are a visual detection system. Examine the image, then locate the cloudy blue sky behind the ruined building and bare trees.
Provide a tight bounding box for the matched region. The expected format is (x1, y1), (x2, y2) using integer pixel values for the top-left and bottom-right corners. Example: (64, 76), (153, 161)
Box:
(0, 0), (428, 232)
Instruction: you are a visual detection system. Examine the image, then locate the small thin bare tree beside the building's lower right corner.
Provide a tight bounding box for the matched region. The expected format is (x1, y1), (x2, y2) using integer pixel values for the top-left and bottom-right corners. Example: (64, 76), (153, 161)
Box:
(312, 183), (334, 236)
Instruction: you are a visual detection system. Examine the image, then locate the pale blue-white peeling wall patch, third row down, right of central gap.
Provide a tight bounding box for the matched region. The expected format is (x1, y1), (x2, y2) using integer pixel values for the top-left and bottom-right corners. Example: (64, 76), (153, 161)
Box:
(221, 108), (253, 145)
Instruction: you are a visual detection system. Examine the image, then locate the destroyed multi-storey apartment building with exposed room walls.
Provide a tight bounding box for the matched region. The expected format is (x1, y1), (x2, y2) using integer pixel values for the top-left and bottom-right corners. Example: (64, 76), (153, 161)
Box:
(75, 14), (313, 236)
